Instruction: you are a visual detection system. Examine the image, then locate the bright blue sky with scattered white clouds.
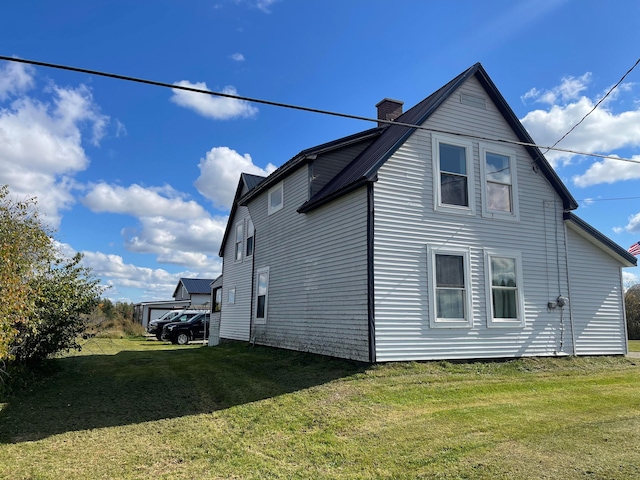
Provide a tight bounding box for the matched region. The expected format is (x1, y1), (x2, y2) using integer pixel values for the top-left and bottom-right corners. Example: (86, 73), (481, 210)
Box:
(0, 0), (640, 302)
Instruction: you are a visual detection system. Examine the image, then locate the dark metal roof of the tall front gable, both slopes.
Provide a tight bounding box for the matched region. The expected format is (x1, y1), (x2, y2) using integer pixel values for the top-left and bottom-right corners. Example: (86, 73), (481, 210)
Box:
(298, 63), (578, 212)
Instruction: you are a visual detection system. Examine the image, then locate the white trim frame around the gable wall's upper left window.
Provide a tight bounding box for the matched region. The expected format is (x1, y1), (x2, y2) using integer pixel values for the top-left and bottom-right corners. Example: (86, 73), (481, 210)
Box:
(431, 133), (476, 215)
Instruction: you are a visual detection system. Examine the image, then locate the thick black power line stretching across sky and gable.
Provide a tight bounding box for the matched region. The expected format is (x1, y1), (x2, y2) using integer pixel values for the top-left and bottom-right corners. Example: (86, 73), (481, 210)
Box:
(0, 55), (640, 164)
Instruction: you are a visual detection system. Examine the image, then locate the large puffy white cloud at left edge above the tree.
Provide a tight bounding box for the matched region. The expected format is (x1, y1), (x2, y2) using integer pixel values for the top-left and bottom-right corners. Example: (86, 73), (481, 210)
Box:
(0, 68), (109, 227)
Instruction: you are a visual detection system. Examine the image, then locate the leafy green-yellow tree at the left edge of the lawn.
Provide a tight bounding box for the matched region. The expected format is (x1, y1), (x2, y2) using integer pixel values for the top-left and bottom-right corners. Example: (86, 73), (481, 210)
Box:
(0, 185), (102, 362)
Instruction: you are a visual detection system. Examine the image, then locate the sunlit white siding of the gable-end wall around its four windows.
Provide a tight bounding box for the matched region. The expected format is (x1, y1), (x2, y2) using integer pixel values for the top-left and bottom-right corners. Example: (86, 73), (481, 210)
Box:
(374, 78), (572, 361)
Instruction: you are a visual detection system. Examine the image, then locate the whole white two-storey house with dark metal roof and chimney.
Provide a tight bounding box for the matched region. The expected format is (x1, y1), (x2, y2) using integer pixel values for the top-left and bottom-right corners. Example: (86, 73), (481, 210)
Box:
(214, 64), (636, 362)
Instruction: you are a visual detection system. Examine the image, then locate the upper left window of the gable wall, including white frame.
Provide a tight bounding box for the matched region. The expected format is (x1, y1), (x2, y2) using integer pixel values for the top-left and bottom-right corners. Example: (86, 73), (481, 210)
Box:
(432, 135), (475, 214)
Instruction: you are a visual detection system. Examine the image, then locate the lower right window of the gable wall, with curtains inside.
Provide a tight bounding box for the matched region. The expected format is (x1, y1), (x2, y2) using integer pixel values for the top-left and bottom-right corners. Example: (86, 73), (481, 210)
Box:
(485, 252), (524, 327)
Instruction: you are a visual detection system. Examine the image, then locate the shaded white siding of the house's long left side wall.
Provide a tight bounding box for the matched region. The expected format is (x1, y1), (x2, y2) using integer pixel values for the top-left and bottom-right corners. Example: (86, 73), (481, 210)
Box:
(248, 166), (369, 361)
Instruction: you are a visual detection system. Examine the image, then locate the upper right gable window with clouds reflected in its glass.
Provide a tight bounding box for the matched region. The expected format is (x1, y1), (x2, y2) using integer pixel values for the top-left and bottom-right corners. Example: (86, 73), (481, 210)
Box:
(480, 144), (518, 219)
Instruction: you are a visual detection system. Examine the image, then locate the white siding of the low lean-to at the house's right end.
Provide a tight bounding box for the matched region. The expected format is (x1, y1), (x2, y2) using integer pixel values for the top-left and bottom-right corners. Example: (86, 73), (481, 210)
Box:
(564, 228), (627, 355)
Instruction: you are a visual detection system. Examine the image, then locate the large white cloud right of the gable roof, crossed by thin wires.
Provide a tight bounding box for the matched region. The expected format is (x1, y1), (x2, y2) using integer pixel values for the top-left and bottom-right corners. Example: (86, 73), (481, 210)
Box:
(521, 74), (640, 167)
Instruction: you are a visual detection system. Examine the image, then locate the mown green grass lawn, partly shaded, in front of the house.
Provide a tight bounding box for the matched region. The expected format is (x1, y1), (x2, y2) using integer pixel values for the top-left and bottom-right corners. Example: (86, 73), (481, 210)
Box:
(0, 339), (640, 479)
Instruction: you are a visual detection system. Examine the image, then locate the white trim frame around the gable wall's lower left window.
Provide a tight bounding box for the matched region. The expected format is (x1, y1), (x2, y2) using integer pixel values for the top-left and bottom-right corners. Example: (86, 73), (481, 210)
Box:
(427, 245), (473, 328)
